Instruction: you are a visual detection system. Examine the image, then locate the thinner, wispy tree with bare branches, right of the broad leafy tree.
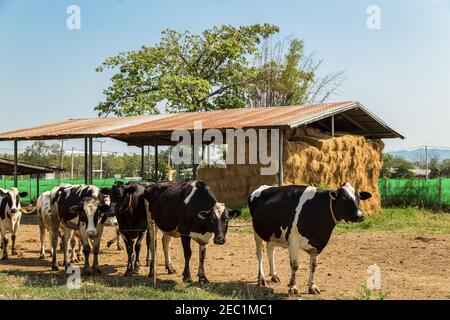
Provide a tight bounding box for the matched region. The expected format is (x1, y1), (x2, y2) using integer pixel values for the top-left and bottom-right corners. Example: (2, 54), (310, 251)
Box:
(249, 37), (345, 107)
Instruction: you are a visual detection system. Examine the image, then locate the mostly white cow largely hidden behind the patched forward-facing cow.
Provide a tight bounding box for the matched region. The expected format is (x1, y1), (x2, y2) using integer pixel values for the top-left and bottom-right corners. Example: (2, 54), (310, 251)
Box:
(33, 190), (83, 262)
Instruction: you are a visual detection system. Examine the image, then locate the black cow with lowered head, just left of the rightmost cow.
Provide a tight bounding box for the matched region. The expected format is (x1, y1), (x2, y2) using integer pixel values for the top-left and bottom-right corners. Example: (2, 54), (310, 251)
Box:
(144, 180), (241, 284)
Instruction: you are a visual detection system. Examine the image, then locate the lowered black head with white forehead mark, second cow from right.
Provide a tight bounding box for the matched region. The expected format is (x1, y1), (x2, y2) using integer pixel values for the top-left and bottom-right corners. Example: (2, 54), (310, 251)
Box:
(197, 202), (241, 244)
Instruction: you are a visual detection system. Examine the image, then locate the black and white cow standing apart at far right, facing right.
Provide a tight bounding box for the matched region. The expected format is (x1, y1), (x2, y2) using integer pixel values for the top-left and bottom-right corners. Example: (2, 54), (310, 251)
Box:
(248, 183), (372, 294)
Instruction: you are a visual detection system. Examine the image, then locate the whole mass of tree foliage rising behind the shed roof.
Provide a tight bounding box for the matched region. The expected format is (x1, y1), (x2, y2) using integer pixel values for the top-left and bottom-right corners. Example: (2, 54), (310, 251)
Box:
(95, 23), (343, 116)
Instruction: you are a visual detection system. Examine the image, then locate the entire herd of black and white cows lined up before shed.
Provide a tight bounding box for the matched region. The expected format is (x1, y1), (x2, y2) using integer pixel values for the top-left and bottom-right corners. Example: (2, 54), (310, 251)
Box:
(0, 180), (371, 294)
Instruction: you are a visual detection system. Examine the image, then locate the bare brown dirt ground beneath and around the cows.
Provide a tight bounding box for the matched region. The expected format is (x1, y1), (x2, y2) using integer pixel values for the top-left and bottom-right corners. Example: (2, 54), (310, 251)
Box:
(0, 216), (450, 299)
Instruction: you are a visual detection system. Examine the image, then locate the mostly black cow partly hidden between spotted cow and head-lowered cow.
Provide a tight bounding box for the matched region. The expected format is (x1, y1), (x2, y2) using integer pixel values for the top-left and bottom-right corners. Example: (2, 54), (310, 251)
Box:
(111, 181), (149, 276)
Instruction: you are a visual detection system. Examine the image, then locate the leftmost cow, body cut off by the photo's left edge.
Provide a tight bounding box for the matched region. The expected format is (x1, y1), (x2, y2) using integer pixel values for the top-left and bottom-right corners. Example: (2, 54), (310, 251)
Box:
(0, 188), (28, 260)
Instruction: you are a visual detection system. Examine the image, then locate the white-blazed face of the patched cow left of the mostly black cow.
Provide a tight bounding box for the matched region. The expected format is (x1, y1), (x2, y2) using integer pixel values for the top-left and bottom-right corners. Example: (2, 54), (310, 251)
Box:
(70, 194), (110, 238)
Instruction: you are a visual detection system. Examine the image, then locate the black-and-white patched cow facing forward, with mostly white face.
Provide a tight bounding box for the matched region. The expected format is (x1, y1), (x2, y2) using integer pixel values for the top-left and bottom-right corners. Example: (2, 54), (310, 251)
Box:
(50, 185), (115, 274)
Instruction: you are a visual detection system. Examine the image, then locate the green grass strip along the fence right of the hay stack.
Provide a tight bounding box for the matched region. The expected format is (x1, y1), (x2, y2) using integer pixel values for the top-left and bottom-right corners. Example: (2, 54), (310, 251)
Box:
(337, 208), (450, 234)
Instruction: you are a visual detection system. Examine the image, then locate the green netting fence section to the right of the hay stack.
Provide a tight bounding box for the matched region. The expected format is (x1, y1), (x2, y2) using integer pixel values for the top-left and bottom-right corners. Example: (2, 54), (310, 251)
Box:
(378, 178), (450, 209)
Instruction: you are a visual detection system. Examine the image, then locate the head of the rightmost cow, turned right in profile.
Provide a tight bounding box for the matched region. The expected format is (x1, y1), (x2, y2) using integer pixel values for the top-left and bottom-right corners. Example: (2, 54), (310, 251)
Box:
(331, 182), (372, 222)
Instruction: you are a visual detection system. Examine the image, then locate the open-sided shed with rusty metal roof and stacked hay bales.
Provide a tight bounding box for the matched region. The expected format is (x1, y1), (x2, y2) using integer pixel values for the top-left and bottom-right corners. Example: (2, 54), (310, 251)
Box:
(0, 101), (404, 214)
